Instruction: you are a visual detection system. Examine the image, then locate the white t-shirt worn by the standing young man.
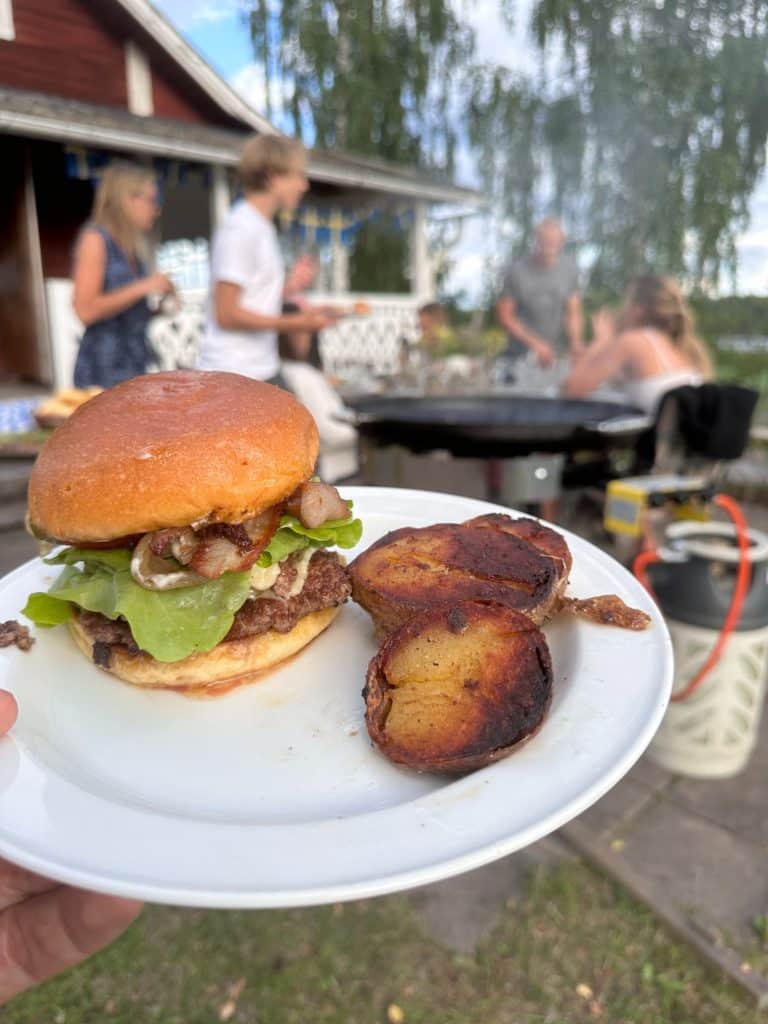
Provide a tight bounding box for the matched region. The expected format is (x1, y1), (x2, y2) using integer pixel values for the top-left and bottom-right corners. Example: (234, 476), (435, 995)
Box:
(198, 200), (286, 381)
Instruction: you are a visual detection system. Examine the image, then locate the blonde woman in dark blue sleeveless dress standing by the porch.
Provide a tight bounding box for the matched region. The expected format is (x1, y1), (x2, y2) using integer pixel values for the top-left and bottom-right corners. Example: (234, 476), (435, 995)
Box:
(73, 163), (173, 387)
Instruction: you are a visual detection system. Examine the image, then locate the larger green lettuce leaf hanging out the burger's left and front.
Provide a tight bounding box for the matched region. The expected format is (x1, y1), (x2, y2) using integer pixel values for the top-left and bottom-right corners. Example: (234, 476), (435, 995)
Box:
(23, 548), (250, 662)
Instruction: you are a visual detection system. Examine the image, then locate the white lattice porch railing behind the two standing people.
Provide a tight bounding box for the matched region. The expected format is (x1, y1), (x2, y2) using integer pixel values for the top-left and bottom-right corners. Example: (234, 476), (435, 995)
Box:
(45, 279), (419, 388)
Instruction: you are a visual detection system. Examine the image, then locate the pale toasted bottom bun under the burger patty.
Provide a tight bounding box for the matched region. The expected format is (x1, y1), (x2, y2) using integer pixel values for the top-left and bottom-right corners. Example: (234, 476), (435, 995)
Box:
(69, 605), (341, 692)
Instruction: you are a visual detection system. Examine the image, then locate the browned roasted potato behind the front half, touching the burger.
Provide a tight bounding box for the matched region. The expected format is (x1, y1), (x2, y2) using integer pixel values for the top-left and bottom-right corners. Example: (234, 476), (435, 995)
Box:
(349, 514), (571, 634)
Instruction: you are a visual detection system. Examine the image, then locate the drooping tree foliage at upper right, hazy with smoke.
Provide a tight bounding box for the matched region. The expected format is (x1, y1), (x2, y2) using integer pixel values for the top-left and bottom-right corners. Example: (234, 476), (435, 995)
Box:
(469, 0), (768, 290)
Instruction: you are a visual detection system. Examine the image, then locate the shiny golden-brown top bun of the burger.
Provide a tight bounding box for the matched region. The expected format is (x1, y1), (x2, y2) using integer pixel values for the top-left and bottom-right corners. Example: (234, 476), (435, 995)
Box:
(29, 370), (318, 544)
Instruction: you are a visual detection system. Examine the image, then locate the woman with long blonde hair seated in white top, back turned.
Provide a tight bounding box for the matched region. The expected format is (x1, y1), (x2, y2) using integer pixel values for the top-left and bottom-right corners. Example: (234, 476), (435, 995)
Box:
(563, 274), (712, 416)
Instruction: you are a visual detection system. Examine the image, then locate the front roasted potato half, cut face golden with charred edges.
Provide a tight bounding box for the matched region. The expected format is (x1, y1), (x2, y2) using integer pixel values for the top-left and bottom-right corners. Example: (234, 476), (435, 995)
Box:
(364, 601), (552, 774)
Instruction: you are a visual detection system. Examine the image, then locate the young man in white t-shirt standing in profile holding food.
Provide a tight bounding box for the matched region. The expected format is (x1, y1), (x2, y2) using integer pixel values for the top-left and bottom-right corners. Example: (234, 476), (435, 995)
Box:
(198, 135), (335, 384)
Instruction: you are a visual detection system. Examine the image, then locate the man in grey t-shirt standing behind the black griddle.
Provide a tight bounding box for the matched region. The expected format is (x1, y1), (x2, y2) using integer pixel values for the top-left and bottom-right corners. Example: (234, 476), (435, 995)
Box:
(496, 218), (584, 367)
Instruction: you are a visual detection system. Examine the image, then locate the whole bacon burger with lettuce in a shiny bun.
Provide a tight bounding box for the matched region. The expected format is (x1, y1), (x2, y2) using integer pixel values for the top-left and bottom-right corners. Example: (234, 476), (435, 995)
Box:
(24, 371), (362, 689)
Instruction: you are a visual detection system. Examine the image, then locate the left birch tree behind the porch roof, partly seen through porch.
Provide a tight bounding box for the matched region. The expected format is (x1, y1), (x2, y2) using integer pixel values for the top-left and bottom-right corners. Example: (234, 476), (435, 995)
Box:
(247, 0), (474, 292)
